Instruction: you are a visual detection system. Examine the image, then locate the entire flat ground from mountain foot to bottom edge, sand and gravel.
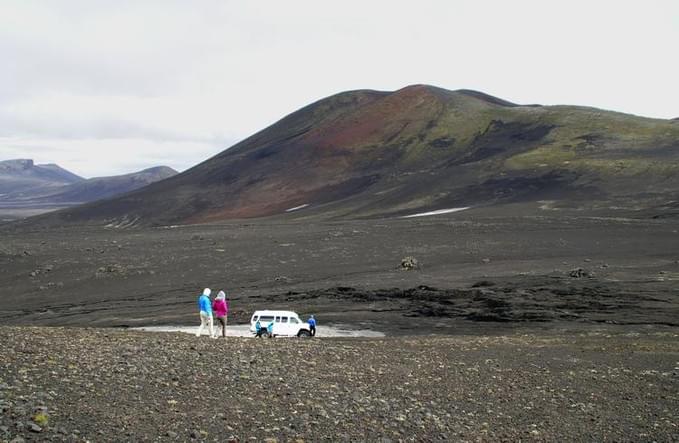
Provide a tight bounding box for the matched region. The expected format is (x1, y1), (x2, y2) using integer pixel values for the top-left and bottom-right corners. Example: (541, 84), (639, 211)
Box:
(0, 206), (679, 441)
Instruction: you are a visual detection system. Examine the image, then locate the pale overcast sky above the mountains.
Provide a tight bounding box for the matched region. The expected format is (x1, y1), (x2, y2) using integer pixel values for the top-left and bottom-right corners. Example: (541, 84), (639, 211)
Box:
(0, 0), (679, 177)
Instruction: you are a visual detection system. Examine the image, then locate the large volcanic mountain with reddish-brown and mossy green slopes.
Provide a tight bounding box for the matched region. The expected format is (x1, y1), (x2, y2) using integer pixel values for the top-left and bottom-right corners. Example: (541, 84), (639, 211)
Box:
(18, 85), (679, 225)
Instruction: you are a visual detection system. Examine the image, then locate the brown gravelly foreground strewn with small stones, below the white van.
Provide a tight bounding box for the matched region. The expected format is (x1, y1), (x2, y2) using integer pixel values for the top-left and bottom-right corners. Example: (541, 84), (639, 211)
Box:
(0, 327), (679, 442)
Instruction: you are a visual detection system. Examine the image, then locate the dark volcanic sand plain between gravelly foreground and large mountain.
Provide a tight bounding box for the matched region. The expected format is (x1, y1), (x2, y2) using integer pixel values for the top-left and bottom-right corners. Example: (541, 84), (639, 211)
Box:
(0, 206), (679, 335)
